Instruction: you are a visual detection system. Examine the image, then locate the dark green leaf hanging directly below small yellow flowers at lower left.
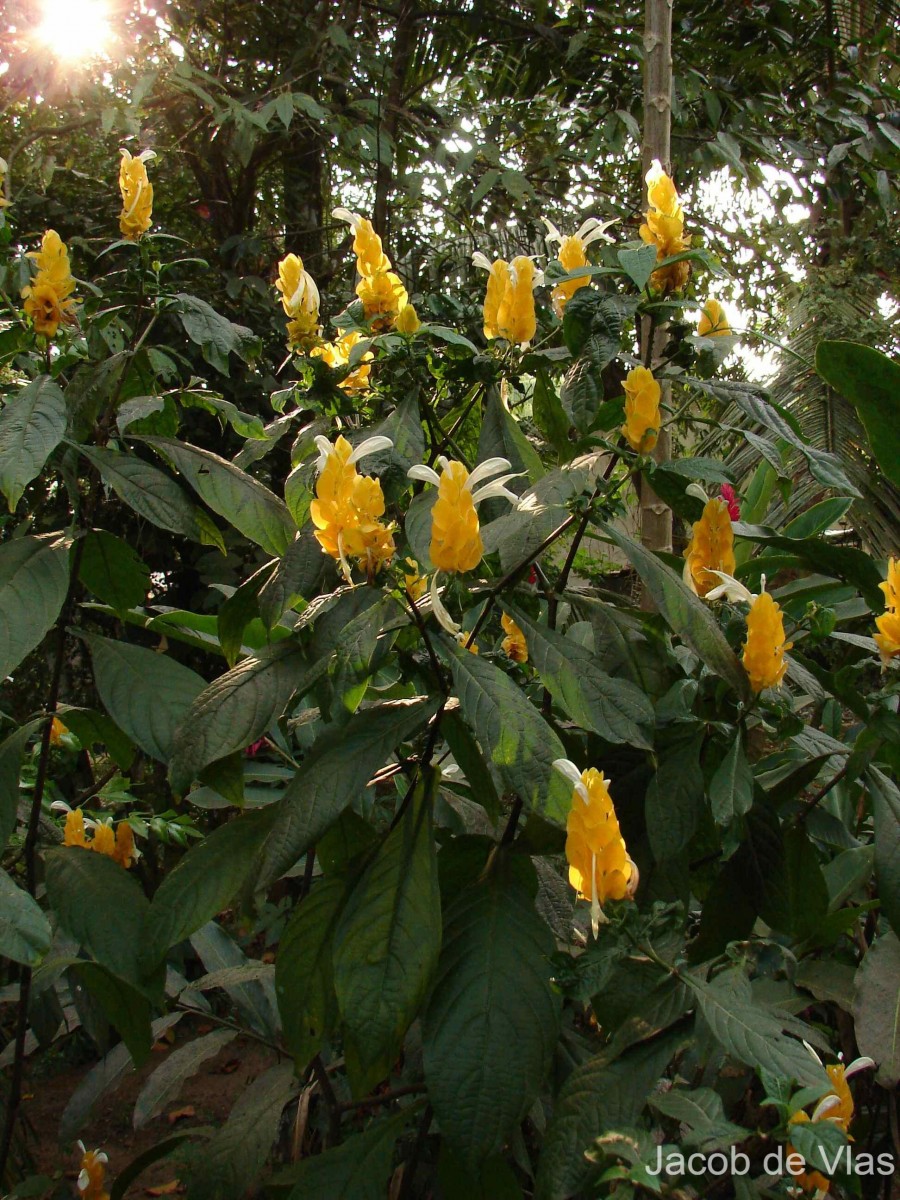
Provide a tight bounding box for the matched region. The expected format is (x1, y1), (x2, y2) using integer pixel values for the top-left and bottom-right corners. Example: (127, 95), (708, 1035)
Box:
(44, 846), (150, 988)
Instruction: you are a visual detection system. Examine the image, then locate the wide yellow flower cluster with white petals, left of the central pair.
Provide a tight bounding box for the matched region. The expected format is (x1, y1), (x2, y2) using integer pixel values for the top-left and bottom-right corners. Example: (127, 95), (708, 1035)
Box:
(310, 437), (395, 582)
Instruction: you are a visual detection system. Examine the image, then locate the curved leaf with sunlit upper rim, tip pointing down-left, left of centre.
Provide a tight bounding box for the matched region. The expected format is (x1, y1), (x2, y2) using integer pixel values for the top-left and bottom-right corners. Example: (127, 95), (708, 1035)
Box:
(169, 643), (314, 792)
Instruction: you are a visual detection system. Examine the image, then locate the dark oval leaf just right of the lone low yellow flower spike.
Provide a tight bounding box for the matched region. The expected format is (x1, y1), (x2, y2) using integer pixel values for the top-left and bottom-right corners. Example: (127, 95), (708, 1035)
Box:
(644, 732), (704, 863)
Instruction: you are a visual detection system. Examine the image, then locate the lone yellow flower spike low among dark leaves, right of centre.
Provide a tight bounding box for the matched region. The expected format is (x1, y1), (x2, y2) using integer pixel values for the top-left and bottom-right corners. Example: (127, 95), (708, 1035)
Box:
(553, 758), (637, 937)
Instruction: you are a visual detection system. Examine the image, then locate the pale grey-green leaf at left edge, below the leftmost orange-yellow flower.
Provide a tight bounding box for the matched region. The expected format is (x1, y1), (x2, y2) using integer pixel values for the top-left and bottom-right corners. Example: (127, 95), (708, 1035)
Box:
(0, 376), (67, 512)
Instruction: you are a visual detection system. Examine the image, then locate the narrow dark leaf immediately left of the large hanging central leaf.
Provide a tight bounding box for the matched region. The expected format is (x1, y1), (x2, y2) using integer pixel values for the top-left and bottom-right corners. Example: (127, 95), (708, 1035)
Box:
(275, 878), (347, 1070)
